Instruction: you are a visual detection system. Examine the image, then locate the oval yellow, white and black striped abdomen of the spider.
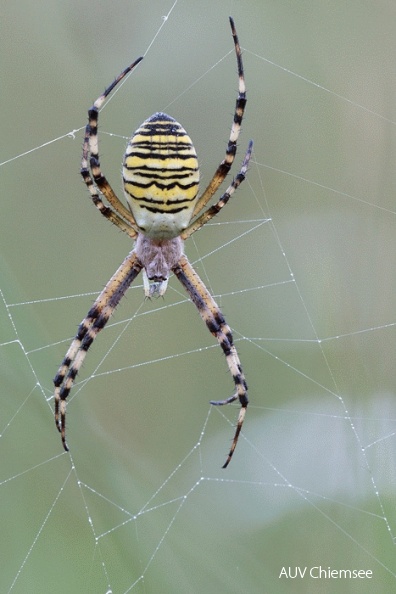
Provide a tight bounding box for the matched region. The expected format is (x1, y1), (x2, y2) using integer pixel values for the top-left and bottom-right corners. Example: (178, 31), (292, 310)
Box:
(122, 113), (199, 240)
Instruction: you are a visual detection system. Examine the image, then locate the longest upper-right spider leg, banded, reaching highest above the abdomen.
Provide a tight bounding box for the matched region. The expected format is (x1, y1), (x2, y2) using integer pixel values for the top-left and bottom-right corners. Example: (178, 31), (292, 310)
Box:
(192, 17), (246, 217)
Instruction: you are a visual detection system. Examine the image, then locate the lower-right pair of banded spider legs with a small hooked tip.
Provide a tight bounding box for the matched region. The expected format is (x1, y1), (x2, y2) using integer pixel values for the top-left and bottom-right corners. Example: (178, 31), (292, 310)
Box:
(172, 255), (249, 468)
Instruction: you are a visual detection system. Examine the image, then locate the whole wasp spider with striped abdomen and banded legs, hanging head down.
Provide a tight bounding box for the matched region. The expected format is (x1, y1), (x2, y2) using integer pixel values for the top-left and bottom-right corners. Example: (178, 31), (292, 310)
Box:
(54, 17), (253, 468)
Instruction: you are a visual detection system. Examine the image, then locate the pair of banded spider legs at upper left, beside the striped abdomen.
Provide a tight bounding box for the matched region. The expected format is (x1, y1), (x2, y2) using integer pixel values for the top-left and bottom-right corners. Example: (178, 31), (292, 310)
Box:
(81, 57), (143, 238)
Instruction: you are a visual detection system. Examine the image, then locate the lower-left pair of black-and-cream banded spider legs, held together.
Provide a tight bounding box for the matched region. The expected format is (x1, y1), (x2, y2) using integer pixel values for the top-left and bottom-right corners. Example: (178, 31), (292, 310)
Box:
(54, 250), (143, 451)
